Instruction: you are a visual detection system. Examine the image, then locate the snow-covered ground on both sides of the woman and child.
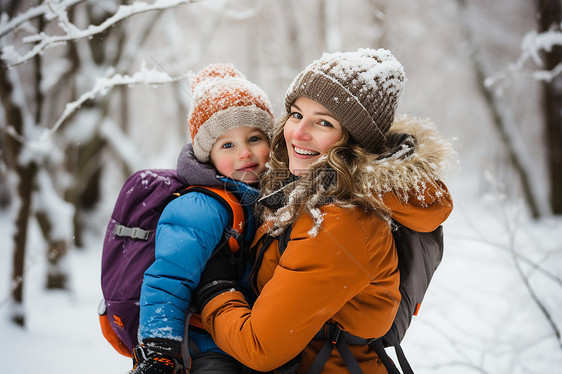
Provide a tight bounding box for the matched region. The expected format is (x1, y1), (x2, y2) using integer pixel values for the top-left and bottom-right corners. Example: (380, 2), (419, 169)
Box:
(0, 186), (562, 374)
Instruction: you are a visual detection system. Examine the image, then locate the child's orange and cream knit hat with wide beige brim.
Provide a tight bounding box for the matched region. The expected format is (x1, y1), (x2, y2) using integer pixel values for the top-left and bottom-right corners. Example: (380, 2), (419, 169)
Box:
(188, 64), (274, 162)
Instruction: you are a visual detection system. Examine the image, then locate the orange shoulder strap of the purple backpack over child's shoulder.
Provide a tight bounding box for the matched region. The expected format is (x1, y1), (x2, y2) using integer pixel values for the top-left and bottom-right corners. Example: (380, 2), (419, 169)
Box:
(182, 186), (244, 252)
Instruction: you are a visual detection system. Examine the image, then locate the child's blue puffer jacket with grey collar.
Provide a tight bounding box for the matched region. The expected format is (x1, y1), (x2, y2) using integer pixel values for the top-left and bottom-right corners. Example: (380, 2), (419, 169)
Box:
(139, 144), (258, 354)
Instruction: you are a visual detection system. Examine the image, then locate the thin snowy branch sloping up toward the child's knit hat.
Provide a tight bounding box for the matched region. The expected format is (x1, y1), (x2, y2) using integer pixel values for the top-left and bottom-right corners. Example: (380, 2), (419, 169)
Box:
(43, 65), (189, 140)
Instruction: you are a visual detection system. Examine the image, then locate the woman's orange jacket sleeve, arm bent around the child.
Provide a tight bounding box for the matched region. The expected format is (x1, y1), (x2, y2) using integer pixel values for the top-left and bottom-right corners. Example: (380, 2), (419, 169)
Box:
(201, 207), (397, 371)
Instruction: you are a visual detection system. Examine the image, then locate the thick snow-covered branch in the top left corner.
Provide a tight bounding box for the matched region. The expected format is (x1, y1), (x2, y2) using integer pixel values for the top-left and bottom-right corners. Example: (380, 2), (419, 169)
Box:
(0, 0), (201, 66)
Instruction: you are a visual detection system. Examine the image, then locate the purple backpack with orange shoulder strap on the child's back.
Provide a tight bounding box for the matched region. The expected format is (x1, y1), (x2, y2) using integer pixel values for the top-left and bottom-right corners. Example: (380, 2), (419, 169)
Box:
(99, 170), (244, 357)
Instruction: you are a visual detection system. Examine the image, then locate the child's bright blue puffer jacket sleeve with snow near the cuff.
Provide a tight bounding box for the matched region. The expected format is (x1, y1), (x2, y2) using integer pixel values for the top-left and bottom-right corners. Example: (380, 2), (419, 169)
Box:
(139, 192), (228, 341)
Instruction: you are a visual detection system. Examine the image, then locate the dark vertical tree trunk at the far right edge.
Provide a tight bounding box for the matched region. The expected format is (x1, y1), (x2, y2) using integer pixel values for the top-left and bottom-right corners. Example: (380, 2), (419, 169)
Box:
(538, 0), (562, 215)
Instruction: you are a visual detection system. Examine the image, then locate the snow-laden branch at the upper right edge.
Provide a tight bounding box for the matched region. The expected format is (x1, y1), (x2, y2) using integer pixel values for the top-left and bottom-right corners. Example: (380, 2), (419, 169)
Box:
(485, 24), (562, 87)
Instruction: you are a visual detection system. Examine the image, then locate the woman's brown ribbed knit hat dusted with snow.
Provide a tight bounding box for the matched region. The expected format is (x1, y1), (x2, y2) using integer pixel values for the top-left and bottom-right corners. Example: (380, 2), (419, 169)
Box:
(285, 48), (405, 153)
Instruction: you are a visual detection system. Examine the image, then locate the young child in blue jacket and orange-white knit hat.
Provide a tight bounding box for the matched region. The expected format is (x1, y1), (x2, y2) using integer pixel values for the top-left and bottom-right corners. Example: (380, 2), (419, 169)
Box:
(133, 64), (273, 374)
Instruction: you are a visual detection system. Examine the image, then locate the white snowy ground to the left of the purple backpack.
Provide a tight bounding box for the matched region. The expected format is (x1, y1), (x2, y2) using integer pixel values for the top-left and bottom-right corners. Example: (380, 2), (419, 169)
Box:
(0, 214), (132, 374)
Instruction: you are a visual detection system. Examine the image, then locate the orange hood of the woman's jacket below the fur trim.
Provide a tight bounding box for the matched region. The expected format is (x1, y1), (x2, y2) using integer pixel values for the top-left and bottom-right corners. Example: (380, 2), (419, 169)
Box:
(383, 182), (453, 232)
